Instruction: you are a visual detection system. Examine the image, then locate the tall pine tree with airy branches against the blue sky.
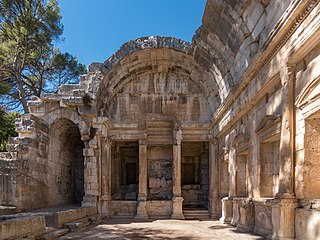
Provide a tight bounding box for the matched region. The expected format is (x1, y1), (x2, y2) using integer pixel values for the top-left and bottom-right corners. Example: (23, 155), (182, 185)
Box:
(0, 0), (85, 112)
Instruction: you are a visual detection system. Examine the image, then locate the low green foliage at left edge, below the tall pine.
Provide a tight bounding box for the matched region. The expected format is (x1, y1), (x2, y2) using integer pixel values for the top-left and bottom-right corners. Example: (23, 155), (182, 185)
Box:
(0, 109), (20, 152)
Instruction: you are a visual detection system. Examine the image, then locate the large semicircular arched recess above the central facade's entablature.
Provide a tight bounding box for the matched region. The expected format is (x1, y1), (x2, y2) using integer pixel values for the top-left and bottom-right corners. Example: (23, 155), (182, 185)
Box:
(97, 48), (220, 122)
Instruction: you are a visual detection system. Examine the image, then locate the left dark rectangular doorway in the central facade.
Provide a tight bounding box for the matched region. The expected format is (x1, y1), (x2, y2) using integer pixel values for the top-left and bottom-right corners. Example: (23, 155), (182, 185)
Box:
(111, 141), (139, 201)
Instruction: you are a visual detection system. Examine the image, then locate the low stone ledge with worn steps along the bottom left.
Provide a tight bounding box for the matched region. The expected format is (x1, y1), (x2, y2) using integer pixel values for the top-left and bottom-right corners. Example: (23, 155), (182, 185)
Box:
(0, 205), (102, 240)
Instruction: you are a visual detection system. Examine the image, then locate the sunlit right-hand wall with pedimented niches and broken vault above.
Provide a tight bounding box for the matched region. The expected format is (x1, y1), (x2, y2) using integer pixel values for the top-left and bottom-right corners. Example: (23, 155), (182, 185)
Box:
(205, 1), (319, 239)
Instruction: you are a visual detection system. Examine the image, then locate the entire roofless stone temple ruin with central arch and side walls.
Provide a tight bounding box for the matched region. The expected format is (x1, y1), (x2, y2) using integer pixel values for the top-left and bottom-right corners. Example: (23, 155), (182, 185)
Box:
(0, 0), (320, 239)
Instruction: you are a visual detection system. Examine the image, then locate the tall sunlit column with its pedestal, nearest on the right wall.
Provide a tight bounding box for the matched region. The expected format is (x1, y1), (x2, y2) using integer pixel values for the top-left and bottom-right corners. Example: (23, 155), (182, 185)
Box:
(272, 67), (298, 239)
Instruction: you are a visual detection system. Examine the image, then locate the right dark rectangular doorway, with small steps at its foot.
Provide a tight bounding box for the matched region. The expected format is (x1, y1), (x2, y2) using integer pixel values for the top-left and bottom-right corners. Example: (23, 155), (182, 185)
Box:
(181, 142), (209, 208)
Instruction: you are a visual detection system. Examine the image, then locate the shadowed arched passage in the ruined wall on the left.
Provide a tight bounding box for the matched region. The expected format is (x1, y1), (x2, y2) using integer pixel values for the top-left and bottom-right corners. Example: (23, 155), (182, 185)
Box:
(47, 118), (84, 205)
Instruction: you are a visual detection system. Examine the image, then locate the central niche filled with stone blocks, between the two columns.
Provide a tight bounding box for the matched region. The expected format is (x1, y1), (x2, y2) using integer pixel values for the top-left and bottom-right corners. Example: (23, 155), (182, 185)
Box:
(148, 145), (173, 200)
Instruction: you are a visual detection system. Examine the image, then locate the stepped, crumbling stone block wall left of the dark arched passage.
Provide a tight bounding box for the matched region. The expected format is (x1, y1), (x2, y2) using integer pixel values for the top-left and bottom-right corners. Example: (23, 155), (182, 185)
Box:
(1, 115), (49, 211)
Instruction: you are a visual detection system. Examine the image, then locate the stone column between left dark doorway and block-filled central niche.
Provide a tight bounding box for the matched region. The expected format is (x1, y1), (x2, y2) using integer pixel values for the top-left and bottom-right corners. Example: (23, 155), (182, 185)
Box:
(135, 140), (149, 219)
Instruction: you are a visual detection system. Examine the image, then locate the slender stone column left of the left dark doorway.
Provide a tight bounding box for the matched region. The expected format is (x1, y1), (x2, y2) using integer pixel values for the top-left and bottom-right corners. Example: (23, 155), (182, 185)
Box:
(100, 138), (112, 217)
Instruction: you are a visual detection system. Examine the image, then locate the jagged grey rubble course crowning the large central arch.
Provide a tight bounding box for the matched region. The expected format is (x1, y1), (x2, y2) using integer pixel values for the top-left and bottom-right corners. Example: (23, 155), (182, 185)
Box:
(88, 36), (191, 74)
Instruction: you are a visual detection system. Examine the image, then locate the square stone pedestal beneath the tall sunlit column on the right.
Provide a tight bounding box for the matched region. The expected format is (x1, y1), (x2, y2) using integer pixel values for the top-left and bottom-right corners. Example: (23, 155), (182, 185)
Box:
(272, 198), (299, 240)
